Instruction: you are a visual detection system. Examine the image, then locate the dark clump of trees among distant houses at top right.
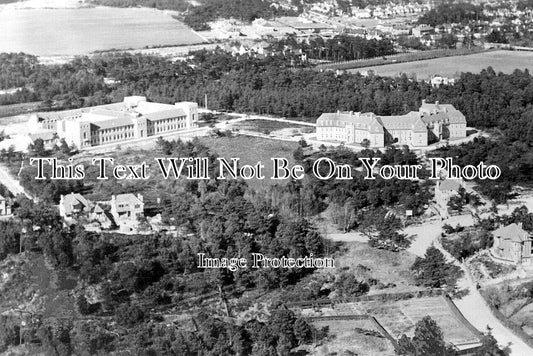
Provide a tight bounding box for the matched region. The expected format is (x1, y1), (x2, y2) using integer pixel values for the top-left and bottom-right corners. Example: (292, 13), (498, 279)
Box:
(418, 2), (487, 26)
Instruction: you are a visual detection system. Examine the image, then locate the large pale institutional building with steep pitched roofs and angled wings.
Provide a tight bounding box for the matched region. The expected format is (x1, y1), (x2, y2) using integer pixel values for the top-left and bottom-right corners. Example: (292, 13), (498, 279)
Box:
(316, 100), (466, 147)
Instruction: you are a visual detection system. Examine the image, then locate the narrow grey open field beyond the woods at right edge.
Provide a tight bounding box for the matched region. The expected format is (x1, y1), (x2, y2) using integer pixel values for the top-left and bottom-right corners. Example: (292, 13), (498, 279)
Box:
(350, 50), (533, 79)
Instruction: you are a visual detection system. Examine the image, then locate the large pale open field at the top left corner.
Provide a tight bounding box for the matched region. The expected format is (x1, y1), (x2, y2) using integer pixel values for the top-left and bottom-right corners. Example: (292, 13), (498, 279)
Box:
(0, 7), (204, 56)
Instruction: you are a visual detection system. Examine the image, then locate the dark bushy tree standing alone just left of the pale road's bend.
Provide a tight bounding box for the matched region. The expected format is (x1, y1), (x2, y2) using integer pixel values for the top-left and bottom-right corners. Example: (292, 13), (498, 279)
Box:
(411, 246), (462, 288)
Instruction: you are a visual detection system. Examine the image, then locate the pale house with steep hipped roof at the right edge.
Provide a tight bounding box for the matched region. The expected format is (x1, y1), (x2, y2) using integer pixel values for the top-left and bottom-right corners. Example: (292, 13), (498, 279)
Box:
(490, 223), (533, 265)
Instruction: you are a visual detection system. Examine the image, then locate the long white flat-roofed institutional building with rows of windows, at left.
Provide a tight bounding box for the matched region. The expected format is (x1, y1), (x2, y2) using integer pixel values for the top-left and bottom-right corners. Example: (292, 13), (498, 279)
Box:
(30, 96), (198, 149)
